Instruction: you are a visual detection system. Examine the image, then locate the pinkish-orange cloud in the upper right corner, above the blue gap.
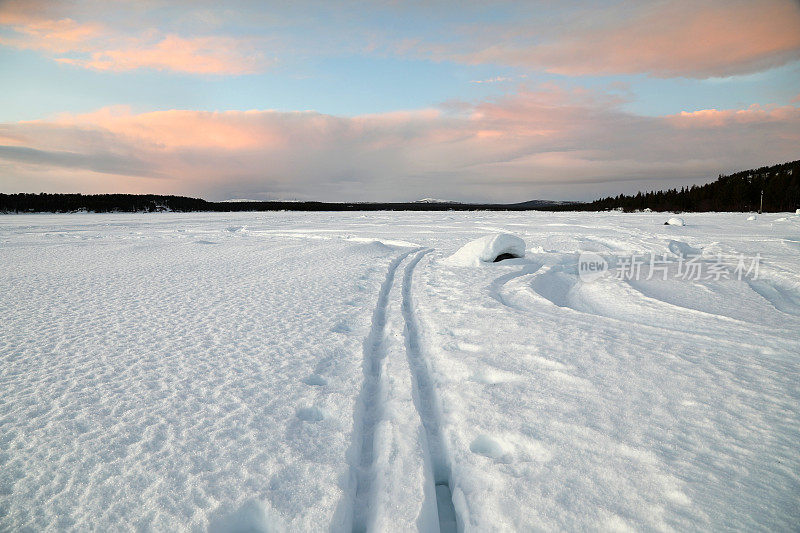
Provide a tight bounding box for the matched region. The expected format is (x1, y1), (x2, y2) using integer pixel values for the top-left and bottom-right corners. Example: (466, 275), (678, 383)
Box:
(416, 0), (800, 78)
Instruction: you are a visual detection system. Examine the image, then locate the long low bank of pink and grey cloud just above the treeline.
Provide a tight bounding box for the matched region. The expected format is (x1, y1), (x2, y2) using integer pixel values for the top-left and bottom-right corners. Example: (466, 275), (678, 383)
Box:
(0, 86), (800, 201)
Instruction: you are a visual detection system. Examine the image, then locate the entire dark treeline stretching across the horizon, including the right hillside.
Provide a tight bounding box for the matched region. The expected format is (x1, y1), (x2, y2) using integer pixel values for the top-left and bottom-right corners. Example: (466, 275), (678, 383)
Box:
(0, 161), (800, 213)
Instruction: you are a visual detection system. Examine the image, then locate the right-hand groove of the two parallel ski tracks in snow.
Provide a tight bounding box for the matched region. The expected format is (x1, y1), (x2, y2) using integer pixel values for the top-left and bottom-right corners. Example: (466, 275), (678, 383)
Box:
(402, 250), (457, 533)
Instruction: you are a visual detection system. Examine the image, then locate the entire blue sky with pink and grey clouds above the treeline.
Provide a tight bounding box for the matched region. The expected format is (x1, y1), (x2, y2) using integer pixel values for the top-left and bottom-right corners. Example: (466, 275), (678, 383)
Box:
(0, 0), (800, 201)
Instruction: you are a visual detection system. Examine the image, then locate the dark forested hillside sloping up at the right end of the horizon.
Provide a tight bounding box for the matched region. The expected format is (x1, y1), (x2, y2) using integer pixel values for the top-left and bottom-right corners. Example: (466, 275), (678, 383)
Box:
(573, 161), (800, 212)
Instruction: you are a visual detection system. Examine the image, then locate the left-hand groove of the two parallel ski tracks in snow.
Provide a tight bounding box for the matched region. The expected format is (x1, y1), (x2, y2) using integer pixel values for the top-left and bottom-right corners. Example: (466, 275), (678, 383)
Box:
(353, 250), (414, 532)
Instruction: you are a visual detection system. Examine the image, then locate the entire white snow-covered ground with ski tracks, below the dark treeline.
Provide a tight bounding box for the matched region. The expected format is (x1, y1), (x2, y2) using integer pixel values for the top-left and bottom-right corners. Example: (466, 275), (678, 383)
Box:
(0, 212), (800, 531)
